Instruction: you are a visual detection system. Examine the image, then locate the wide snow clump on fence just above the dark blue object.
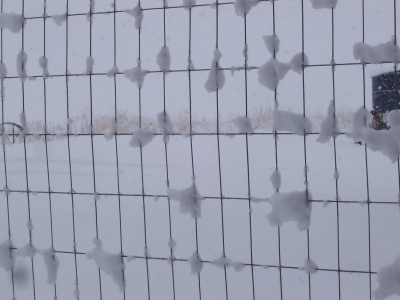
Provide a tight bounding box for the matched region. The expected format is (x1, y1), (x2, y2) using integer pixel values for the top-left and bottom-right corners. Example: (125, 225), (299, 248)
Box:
(353, 40), (400, 64)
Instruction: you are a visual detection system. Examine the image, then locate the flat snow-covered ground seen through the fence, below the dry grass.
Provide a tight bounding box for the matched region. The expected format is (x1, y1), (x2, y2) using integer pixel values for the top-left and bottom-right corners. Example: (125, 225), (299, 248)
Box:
(0, 135), (400, 299)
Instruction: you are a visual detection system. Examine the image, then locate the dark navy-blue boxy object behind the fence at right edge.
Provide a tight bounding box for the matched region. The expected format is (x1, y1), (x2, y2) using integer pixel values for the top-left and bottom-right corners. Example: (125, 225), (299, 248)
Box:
(370, 71), (400, 130)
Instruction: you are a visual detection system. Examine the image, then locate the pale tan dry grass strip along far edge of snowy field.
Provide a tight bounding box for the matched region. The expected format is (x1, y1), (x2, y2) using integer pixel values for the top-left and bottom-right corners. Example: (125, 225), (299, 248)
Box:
(6, 107), (354, 141)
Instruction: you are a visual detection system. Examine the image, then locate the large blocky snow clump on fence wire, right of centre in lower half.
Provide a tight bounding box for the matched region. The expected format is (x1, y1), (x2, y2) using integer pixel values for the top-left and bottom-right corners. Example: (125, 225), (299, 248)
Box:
(267, 191), (311, 231)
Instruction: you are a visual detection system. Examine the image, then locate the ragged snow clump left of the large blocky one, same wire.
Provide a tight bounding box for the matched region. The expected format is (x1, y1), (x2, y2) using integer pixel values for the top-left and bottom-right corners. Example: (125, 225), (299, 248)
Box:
(168, 182), (205, 219)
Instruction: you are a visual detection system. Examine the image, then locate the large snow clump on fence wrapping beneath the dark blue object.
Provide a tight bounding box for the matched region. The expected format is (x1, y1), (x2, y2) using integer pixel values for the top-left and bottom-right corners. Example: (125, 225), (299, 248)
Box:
(347, 107), (400, 163)
